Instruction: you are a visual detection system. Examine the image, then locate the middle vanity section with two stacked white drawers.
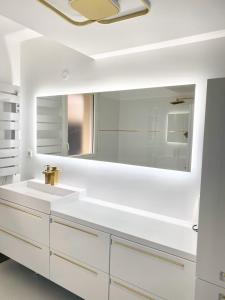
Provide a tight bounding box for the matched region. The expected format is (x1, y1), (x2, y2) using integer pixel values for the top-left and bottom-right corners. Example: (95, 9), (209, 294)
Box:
(50, 217), (110, 300)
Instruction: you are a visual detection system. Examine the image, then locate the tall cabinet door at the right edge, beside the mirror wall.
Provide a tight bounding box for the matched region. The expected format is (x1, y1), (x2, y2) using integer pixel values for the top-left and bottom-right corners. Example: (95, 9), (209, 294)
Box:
(197, 79), (225, 288)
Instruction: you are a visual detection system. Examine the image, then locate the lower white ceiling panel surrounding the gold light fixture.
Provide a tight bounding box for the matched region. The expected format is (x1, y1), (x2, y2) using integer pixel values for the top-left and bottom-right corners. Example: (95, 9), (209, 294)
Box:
(0, 0), (225, 56)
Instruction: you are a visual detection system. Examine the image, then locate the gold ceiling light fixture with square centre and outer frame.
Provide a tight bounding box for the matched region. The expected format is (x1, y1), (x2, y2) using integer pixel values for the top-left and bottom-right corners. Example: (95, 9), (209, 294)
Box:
(37, 0), (151, 26)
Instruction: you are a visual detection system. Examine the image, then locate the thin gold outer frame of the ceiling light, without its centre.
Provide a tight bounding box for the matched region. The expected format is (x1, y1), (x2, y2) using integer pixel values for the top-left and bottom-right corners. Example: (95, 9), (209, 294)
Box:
(37, 0), (151, 26)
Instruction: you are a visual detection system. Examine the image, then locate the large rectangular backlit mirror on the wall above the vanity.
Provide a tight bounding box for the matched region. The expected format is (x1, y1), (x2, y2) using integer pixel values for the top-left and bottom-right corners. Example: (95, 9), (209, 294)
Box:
(37, 85), (195, 171)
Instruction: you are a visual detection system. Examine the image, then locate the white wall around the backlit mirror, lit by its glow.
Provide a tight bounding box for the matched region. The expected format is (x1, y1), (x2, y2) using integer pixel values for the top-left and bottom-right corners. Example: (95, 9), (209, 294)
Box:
(21, 38), (225, 221)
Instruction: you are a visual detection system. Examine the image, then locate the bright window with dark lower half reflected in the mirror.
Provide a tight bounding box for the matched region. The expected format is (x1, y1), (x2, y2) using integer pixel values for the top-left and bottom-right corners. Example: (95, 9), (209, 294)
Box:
(67, 94), (94, 156)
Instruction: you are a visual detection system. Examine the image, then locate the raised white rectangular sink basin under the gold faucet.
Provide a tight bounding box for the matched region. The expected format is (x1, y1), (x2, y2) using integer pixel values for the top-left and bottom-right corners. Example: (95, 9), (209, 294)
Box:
(0, 180), (85, 214)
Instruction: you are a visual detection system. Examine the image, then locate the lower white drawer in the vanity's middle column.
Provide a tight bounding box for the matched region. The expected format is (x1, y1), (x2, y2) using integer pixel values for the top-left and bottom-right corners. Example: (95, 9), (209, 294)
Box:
(50, 253), (109, 300)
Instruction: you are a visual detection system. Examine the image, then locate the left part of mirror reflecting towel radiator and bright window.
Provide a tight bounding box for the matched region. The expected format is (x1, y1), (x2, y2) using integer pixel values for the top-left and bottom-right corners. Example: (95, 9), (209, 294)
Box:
(37, 94), (94, 156)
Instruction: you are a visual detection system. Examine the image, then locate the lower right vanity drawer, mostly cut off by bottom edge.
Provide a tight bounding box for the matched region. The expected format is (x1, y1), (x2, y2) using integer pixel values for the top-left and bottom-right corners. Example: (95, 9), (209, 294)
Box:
(109, 278), (162, 300)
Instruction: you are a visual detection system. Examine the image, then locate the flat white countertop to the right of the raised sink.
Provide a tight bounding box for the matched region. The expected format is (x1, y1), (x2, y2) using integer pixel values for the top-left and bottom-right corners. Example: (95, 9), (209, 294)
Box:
(52, 198), (197, 261)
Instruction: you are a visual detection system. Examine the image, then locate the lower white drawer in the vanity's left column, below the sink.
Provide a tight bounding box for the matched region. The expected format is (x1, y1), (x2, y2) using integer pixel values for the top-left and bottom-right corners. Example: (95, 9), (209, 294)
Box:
(0, 228), (49, 278)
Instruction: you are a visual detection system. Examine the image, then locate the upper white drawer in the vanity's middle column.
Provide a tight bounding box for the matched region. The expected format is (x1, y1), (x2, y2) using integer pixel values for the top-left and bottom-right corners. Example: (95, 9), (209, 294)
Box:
(50, 218), (110, 273)
